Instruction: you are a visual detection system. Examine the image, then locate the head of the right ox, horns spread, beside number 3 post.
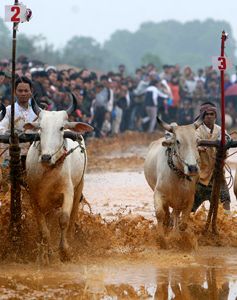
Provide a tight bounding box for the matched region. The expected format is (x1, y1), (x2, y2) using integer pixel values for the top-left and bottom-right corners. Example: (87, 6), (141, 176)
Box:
(157, 115), (203, 176)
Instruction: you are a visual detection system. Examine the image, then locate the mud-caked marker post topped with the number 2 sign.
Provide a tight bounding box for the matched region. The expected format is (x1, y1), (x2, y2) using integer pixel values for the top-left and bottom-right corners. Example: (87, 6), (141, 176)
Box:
(0, 0), (32, 254)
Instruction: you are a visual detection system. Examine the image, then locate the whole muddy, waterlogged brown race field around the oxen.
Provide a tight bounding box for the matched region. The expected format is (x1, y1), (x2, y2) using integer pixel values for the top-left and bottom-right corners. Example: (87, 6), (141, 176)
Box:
(0, 133), (237, 299)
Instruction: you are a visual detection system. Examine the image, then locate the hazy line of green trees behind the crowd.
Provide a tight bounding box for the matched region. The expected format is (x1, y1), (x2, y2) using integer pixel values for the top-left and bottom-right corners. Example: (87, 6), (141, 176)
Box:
(0, 18), (236, 72)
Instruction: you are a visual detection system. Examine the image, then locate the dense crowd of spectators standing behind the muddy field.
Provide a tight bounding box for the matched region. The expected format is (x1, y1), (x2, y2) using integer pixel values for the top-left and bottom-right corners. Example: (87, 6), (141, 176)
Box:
(0, 56), (237, 137)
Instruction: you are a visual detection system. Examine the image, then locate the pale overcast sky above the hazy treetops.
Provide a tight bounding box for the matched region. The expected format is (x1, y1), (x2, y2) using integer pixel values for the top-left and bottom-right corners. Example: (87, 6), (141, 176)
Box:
(0, 0), (237, 47)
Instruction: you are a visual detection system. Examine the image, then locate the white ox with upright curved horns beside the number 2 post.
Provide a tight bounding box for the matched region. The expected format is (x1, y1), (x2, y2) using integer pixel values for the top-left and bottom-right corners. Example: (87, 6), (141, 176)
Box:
(24, 96), (93, 262)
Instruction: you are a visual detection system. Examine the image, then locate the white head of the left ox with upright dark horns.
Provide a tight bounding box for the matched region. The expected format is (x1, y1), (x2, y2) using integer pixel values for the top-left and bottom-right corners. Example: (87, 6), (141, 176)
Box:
(24, 95), (93, 165)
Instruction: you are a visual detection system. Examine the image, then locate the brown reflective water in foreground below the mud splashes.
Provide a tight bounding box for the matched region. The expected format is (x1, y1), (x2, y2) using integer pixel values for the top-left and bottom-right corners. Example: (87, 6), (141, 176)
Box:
(0, 260), (237, 300)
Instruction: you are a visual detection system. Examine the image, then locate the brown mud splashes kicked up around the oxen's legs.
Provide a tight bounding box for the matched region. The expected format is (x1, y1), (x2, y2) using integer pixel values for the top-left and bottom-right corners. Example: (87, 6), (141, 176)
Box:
(0, 190), (237, 262)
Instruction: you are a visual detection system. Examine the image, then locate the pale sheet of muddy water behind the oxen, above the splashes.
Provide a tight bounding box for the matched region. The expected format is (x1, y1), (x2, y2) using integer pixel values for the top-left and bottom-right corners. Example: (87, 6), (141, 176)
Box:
(84, 170), (237, 220)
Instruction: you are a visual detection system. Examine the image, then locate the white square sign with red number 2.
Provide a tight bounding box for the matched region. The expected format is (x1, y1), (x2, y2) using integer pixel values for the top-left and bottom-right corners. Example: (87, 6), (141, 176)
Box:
(5, 5), (26, 23)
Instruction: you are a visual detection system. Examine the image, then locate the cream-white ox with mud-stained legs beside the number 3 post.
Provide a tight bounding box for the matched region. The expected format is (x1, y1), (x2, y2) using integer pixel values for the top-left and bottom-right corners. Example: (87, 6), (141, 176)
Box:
(144, 117), (201, 235)
